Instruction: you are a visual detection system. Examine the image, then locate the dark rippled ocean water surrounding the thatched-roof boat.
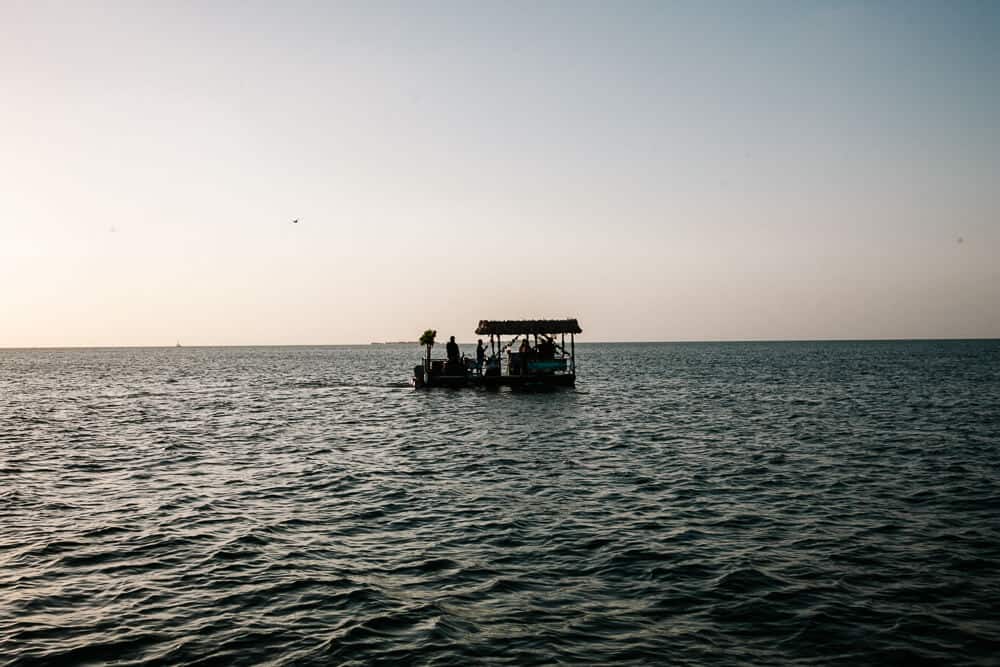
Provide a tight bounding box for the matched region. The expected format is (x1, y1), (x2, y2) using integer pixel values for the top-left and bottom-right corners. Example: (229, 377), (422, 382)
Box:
(0, 341), (1000, 665)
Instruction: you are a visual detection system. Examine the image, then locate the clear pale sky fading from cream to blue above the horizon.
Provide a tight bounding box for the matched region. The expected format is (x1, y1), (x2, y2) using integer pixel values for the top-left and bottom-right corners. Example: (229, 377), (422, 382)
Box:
(0, 0), (1000, 347)
